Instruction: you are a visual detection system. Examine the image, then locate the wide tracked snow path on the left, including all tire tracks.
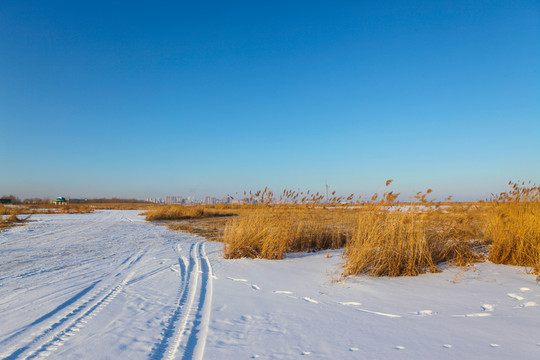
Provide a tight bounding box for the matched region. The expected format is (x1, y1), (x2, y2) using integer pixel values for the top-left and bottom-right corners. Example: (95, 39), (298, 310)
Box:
(0, 211), (213, 359)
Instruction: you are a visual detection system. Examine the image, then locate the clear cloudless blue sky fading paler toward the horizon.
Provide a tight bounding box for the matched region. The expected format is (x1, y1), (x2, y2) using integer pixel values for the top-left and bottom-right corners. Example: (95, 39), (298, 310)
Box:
(0, 0), (540, 199)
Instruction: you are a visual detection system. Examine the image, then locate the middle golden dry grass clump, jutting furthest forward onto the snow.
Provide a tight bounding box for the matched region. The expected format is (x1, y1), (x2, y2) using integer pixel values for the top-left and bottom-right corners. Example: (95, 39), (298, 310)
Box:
(343, 182), (482, 276)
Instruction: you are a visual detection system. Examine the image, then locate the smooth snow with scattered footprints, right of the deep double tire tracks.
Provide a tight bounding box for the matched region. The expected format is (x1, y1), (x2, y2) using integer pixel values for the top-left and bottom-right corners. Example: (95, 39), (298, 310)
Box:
(206, 244), (540, 359)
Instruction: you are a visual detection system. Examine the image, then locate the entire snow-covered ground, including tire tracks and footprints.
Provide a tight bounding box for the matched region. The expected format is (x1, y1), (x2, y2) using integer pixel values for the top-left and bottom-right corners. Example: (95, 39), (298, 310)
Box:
(0, 211), (540, 359)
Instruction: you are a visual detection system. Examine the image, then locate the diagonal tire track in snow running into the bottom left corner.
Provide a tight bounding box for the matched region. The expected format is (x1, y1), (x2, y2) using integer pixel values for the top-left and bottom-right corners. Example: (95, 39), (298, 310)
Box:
(2, 249), (148, 360)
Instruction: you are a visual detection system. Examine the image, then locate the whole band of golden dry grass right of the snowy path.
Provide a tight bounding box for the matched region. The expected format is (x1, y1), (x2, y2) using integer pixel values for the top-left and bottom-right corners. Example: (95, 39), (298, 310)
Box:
(156, 181), (540, 276)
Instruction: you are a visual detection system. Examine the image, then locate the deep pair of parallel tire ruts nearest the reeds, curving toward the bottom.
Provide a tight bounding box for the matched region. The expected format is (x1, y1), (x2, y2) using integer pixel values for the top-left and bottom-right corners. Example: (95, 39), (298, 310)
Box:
(150, 241), (213, 360)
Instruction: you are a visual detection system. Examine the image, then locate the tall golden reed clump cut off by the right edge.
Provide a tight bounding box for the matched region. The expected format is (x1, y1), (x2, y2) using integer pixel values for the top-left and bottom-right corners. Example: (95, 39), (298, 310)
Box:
(486, 182), (540, 274)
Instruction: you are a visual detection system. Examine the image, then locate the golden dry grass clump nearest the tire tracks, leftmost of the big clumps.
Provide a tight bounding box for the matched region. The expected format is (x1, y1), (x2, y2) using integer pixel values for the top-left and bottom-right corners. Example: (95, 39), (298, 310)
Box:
(223, 189), (352, 259)
